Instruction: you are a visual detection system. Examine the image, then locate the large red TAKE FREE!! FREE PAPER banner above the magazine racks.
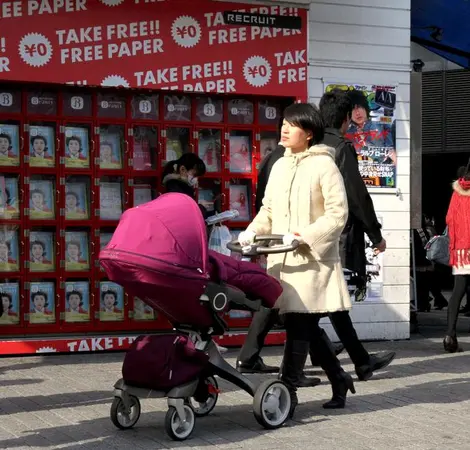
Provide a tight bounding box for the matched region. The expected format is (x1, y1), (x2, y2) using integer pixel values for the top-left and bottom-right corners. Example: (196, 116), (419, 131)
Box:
(0, 0), (308, 98)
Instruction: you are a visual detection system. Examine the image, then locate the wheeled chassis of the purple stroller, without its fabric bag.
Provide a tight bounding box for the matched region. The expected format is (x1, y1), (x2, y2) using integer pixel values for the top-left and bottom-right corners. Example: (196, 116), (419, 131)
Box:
(111, 283), (291, 441)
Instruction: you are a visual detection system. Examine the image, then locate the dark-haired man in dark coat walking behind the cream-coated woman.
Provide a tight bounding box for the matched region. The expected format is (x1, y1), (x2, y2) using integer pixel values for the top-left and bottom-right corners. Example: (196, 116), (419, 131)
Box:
(237, 91), (395, 387)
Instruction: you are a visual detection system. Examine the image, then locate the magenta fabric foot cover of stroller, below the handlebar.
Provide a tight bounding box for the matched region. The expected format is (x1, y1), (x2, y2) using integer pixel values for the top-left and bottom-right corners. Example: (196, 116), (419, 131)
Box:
(209, 250), (282, 308)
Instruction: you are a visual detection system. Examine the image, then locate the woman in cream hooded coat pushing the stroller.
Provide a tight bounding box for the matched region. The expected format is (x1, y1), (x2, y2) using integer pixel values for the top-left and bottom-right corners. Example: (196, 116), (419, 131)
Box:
(239, 104), (355, 417)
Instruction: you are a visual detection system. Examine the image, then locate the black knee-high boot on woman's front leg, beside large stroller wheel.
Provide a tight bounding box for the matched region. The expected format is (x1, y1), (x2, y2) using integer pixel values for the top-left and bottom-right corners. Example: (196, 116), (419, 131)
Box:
(281, 339), (310, 419)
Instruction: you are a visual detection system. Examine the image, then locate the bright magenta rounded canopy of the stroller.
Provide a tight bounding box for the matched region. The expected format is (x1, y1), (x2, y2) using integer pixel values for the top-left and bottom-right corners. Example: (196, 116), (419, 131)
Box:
(100, 193), (208, 283)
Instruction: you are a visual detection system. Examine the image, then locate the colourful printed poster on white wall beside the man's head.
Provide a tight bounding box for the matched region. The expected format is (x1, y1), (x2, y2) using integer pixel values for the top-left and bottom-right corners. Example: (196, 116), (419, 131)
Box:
(324, 81), (397, 188)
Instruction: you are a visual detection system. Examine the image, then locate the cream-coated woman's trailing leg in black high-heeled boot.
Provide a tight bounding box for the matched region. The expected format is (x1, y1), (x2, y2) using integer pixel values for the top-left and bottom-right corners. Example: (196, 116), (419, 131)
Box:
(309, 314), (356, 409)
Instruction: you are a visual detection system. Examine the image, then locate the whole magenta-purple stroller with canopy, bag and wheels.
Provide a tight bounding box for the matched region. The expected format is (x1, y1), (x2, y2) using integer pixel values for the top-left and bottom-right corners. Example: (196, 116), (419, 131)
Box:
(99, 193), (296, 440)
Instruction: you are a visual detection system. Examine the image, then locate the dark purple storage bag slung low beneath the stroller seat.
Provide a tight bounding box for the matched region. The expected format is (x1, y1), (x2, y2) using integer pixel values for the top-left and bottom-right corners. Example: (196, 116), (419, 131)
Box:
(122, 333), (209, 391)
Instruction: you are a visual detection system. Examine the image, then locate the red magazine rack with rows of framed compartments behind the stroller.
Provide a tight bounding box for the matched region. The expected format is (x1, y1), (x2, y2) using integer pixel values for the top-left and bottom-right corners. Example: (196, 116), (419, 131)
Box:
(0, 85), (292, 337)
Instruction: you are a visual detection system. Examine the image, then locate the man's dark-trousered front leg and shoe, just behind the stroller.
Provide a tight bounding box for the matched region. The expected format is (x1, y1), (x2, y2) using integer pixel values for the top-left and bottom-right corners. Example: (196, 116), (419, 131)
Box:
(237, 307), (279, 373)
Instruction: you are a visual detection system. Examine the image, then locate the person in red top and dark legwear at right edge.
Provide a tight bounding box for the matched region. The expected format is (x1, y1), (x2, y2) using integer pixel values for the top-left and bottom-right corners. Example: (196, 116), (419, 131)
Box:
(443, 160), (470, 353)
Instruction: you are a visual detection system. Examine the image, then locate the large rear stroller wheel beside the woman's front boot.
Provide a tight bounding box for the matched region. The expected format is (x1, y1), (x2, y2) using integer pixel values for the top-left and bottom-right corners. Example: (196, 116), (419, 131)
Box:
(253, 380), (291, 430)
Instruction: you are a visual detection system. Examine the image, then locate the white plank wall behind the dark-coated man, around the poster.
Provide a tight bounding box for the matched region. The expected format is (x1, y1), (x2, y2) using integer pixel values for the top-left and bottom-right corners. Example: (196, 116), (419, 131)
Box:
(309, 0), (411, 339)
